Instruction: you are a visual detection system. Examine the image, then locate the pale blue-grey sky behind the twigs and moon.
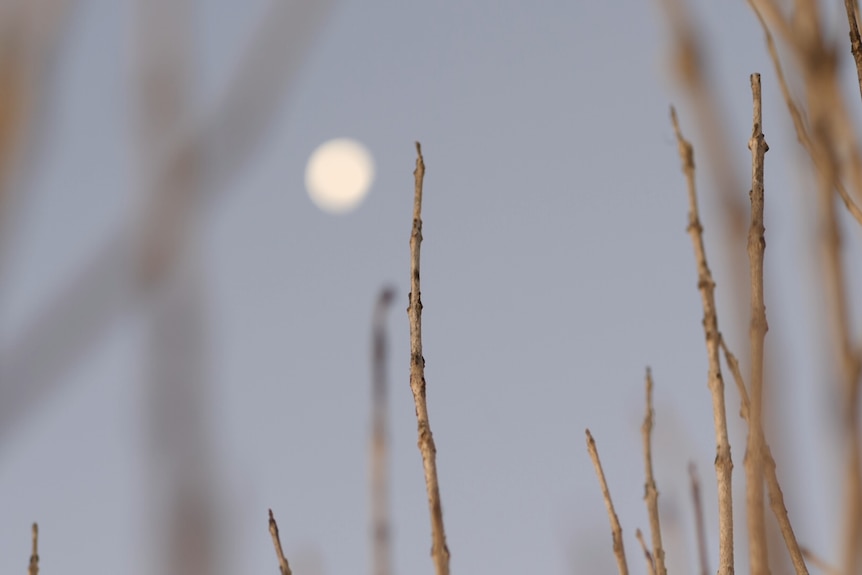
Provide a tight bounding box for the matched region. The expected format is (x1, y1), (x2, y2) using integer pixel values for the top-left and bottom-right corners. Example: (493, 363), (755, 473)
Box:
(0, 0), (860, 575)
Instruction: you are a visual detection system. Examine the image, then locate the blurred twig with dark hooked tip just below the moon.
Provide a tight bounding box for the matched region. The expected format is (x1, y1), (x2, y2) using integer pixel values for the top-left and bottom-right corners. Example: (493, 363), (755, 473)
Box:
(371, 288), (395, 575)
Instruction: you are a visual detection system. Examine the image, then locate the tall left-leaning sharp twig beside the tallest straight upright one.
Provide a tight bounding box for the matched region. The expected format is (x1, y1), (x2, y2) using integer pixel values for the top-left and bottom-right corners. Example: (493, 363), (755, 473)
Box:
(671, 108), (734, 575)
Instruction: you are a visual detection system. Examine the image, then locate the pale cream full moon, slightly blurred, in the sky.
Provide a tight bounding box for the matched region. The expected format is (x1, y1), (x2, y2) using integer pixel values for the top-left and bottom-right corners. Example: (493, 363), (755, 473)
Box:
(305, 138), (374, 214)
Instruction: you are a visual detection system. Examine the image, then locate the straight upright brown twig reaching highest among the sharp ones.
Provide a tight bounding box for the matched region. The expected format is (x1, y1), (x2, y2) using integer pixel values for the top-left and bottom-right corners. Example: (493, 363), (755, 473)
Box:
(745, 74), (769, 575)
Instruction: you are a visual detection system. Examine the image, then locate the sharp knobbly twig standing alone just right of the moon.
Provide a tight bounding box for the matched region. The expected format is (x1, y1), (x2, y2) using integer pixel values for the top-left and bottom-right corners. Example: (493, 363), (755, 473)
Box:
(407, 142), (456, 575)
